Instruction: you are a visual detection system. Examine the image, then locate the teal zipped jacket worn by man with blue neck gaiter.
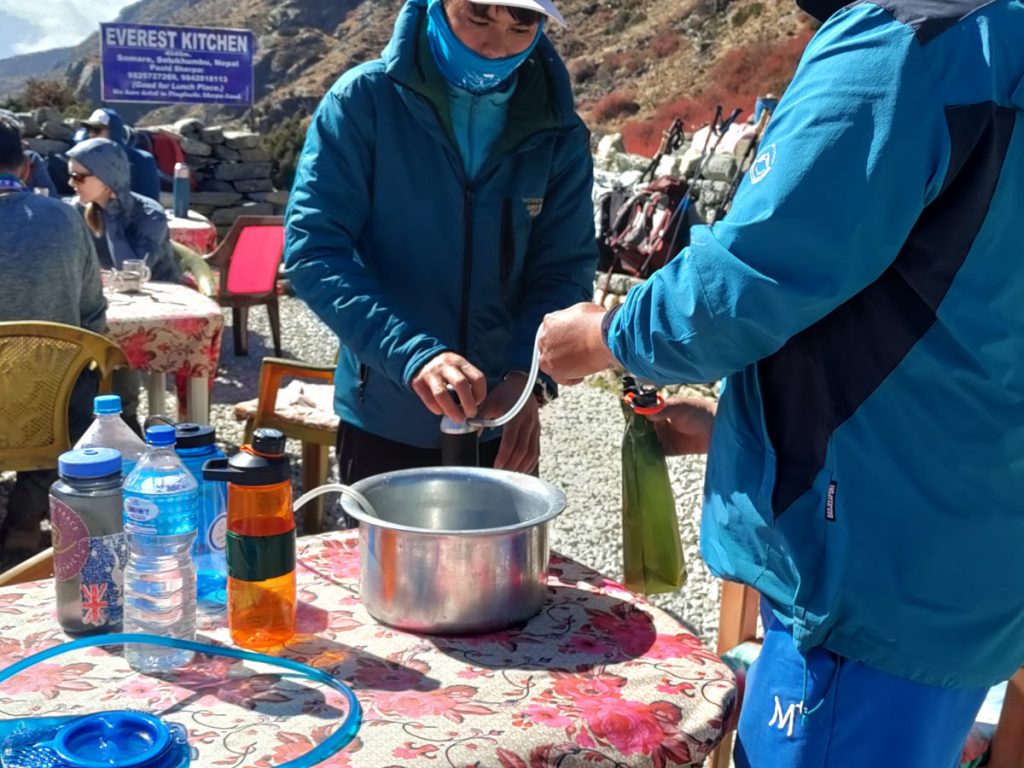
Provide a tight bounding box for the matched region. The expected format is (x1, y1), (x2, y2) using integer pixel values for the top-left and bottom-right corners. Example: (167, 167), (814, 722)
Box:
(285, 0), (597, 447)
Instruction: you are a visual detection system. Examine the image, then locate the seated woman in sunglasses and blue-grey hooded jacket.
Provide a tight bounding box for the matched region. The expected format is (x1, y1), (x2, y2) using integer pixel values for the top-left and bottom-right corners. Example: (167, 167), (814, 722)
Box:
(68, 138), (181, 434)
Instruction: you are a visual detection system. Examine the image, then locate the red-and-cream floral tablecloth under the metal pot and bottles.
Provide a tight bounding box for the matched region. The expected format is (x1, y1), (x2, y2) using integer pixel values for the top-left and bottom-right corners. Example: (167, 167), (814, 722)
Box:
(0, 531), (735, 768)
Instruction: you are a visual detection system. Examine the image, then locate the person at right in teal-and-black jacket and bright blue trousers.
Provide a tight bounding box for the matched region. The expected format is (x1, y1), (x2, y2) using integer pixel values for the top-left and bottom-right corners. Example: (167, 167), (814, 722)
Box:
(541, 0), (1024, 768)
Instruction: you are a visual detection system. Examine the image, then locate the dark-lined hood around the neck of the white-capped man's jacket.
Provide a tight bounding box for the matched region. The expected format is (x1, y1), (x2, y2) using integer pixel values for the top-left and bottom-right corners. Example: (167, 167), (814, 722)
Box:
(381, 0), (578, 125)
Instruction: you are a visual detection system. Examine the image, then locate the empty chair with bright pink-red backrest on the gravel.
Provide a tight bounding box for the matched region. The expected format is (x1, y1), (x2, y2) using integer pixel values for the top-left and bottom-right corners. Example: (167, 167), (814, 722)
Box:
(204, 216), (285, 357)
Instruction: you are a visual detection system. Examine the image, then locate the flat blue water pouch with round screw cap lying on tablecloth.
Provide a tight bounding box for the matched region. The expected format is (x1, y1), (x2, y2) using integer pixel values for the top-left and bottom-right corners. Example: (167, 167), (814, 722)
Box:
(3, 711), (189, 768)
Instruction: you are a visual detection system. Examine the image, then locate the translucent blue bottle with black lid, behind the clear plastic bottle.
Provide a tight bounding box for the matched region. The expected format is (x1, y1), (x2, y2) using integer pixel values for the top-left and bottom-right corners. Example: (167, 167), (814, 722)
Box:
(174, 424), (227, 611)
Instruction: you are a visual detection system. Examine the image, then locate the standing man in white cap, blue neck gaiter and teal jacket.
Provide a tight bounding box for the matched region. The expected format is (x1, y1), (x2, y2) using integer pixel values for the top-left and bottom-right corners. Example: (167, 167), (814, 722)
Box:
(285, 0), (597, 482)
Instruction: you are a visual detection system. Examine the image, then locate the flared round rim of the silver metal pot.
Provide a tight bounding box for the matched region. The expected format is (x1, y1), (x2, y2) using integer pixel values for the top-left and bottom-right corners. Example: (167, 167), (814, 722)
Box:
(341, 467), (567, 538)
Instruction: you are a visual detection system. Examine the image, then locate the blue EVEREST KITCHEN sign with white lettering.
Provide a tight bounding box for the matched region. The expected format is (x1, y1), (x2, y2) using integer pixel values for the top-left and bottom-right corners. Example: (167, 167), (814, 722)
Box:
(99, 23), (255, 105)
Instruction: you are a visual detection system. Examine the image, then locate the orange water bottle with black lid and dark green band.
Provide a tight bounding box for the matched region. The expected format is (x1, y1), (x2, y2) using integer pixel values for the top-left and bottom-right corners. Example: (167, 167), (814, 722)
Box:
(203, 429), (295, 649)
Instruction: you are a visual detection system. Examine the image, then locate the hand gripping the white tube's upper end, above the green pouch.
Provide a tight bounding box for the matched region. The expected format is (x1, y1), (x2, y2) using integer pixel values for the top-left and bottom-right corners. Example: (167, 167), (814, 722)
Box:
(538, 301), (615, 384)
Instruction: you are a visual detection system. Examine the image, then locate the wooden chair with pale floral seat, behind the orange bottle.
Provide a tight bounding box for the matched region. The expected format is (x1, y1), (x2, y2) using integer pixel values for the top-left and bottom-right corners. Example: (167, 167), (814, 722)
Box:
(234, 357), (339, 534)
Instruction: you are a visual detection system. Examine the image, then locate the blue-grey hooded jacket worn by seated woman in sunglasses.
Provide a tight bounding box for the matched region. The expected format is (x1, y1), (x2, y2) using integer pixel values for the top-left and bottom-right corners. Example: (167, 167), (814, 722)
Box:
(68, 138), (181, 283)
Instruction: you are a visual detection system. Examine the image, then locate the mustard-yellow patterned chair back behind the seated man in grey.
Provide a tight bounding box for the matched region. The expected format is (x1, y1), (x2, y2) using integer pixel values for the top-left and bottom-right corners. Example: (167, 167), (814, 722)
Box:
(0, 322), (128, 472)
